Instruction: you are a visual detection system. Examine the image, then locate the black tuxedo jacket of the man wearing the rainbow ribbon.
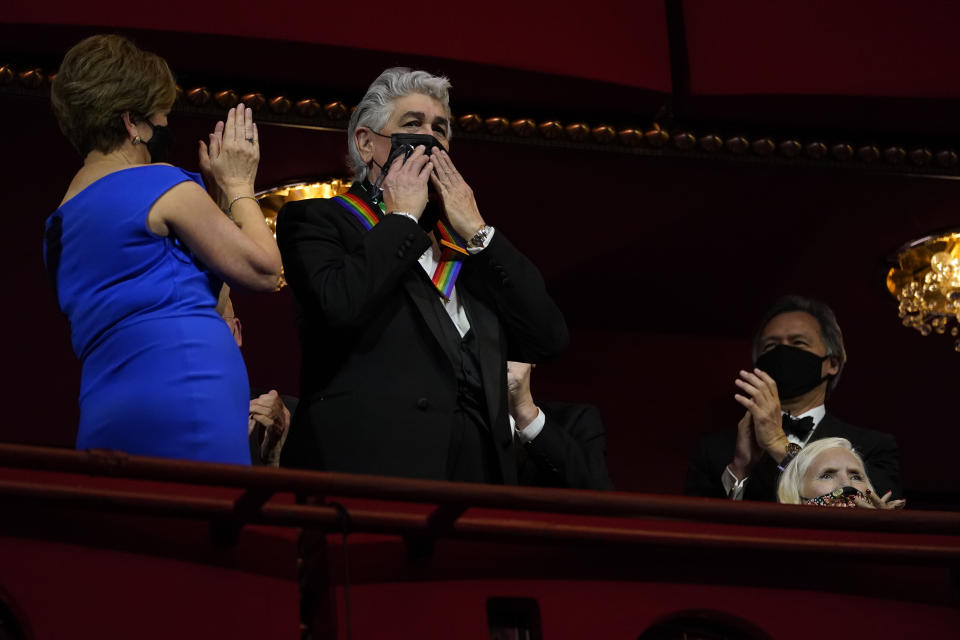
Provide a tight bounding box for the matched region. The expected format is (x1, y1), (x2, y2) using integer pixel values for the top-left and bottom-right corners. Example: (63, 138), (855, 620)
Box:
(277, 185), (568, 484)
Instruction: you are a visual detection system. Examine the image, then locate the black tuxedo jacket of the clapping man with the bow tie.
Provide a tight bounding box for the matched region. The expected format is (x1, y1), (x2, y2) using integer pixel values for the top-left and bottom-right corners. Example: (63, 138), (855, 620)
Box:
(684, 411), (903, 502)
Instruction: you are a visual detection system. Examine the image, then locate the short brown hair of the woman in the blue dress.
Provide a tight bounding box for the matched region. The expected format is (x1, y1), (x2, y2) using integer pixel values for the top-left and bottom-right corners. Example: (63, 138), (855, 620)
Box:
(50, 35), (177, 156)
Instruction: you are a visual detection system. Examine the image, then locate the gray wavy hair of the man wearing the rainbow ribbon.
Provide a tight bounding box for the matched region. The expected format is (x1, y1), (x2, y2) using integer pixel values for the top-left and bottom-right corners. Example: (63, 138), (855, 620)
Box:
(347, 67), (452, 180)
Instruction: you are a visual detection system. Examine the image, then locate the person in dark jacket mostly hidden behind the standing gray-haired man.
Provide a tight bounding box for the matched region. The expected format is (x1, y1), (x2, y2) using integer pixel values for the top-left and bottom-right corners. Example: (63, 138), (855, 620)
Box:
(507, 362), (613, 490)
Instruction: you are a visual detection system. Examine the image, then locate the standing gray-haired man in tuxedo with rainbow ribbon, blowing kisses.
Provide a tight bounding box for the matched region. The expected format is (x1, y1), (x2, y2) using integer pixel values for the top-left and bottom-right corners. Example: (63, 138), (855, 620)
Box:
(277, 68), (568, 484)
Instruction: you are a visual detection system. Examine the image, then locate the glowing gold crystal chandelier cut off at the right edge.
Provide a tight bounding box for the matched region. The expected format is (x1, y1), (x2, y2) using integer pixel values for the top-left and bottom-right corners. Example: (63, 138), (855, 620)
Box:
(887, 230), (960, 351)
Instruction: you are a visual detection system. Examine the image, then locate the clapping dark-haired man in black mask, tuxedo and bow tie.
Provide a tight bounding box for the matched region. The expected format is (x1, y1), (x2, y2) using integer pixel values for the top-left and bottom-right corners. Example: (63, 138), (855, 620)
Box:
(685, 296), (903, 501)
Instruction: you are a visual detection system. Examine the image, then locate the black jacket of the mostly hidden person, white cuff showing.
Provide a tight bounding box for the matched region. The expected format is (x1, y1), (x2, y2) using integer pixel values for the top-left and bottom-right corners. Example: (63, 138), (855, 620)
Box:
(517, 402), (613, 490)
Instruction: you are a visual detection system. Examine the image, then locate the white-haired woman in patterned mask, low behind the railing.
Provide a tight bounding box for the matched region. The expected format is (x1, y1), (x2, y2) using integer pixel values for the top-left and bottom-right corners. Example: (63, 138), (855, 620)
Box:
(777, 438), (906, 509)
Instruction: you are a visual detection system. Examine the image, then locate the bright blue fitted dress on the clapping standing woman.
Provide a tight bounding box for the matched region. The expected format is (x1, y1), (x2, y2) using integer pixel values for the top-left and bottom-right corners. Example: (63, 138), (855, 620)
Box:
(44, 165), (250, 464)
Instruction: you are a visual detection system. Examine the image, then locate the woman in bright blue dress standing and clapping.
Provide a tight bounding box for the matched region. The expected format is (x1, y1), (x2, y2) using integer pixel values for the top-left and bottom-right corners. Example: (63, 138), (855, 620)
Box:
(44, 35), (281, 464)
